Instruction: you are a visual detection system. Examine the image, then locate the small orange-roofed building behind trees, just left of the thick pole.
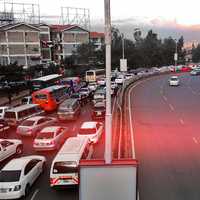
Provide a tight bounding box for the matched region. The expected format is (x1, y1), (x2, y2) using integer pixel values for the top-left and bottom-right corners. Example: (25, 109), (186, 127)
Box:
(90, 32), (105, 50)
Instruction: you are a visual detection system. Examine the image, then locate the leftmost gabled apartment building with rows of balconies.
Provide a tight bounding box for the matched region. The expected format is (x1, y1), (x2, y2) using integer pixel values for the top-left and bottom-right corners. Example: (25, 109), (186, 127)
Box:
(0, 23), (41, 66)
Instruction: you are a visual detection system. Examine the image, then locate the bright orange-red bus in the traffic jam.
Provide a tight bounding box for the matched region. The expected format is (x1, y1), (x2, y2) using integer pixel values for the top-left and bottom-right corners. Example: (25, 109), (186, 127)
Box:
(32, 85), (71, 111)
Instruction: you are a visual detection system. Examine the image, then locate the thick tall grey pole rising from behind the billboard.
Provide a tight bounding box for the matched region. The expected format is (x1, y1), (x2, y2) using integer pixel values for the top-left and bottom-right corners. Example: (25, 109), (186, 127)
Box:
(104, 0), (112, 164)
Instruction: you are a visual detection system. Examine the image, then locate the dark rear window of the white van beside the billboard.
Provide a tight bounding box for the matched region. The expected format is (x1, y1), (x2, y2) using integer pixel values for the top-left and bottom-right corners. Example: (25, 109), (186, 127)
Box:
(53, 161), (78, 174)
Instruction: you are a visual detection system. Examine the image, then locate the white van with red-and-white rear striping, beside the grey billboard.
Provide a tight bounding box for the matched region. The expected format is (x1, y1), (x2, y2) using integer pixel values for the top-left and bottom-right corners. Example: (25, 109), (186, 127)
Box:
(50, 137), (93, 187)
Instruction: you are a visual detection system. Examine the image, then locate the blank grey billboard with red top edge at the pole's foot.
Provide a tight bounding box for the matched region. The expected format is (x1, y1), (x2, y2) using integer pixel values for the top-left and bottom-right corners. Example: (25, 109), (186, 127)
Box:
(79, 160), (138, 200)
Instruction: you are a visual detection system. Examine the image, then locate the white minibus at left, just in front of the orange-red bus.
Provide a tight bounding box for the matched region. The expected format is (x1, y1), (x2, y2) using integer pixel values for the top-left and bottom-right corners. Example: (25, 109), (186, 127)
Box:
(4, 104), (44, 126)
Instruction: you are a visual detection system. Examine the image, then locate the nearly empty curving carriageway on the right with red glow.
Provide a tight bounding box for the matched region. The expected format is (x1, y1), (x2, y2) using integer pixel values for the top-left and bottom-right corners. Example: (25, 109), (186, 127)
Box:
(131, 74), (200, 200)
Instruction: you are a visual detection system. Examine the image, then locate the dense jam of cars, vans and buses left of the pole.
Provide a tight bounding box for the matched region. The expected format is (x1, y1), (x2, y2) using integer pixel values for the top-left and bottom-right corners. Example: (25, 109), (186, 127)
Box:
(0, 69), (119, 199)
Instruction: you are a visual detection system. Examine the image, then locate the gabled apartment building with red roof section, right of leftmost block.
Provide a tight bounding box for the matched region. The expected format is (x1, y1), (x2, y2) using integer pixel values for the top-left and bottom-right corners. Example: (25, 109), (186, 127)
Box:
(50, 25), (89, 63)
